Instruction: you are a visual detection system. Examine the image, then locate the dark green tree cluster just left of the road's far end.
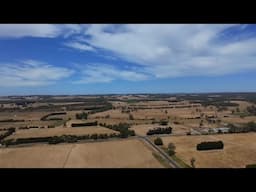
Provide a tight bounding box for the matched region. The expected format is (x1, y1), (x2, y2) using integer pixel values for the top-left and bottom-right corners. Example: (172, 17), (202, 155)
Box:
(99, 123), (135, 138)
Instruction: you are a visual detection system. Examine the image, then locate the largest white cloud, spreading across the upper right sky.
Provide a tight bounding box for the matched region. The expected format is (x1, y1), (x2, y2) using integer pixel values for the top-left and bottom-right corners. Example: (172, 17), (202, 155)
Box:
(73, 24), (256, 78)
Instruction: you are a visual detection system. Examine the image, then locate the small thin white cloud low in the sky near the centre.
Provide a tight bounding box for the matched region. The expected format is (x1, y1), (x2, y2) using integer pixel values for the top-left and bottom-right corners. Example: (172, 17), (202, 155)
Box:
(74, 64), (148, 83)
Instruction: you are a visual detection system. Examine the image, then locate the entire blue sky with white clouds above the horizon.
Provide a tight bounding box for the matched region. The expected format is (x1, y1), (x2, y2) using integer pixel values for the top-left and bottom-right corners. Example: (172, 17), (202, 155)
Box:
(0, 24), (256, 95)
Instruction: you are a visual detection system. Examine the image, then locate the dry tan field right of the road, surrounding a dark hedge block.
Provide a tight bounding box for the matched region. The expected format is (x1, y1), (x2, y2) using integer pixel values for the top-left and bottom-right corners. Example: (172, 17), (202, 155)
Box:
(162, 133), (256, 168)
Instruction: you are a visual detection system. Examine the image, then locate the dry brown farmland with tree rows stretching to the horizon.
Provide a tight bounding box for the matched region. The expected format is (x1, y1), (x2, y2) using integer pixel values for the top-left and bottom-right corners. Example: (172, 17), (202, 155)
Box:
(0, 93), (256, 168)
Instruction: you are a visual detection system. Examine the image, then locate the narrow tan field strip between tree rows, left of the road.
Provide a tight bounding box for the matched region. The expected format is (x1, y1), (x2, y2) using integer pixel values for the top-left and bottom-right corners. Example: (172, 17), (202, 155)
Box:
(6, 126), (118, 139)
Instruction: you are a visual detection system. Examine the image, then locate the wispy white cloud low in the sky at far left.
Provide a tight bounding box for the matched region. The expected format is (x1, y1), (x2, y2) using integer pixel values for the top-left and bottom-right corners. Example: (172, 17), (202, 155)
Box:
(0, 60), (73, 87)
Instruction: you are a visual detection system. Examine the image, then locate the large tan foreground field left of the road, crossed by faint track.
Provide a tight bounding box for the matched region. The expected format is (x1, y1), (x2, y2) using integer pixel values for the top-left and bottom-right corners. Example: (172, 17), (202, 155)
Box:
(0, 139), (163, 168)
